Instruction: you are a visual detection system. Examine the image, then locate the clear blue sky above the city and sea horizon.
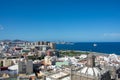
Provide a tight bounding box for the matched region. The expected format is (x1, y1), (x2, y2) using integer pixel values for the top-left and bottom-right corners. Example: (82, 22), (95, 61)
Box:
(0, 0), (120, 42)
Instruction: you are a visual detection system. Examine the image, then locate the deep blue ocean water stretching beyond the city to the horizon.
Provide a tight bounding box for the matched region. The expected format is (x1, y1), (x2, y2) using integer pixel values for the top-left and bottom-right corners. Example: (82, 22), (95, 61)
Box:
(56, 42), (120, 55)
